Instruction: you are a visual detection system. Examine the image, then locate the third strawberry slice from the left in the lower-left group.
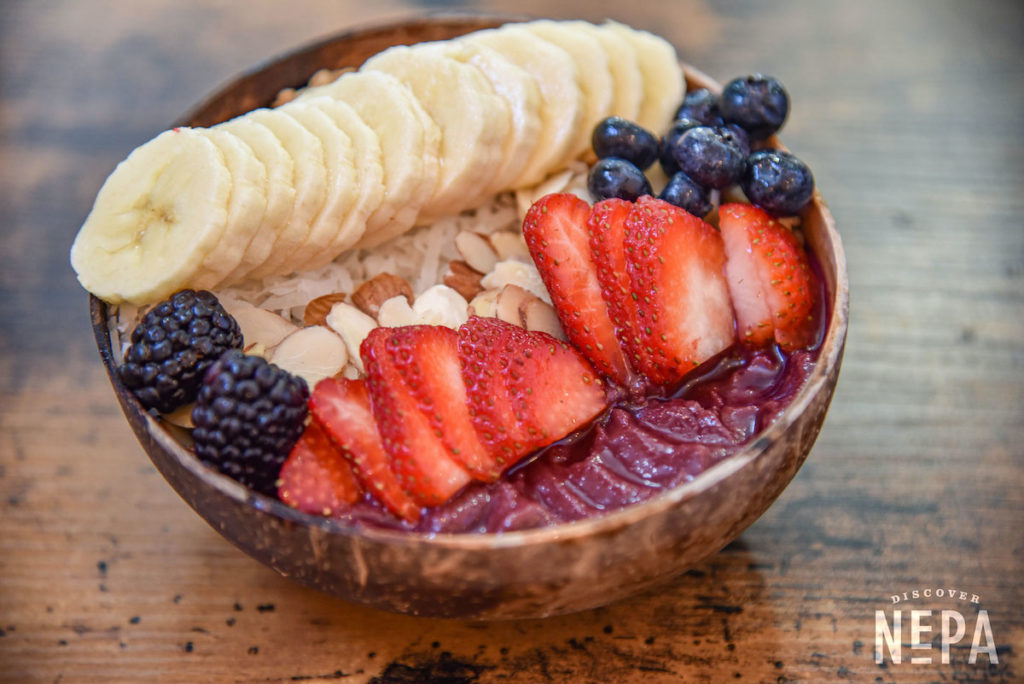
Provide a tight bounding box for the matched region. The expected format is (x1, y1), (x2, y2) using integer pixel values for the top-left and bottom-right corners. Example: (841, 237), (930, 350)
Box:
(359, 328), (470, 506)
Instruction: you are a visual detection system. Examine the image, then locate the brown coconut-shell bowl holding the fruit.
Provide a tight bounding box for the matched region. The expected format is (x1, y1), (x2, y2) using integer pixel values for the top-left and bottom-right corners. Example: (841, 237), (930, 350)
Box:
(90, 15), (849, 619)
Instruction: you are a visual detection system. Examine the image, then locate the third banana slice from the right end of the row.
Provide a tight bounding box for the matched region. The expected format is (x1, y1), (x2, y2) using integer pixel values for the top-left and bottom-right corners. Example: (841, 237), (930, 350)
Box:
(523, 19), (614, 167)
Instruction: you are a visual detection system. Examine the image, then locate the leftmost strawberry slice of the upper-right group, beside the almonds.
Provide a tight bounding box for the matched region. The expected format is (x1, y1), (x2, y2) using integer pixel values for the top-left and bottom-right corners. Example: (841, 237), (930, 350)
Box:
(522, 193), (629, 384)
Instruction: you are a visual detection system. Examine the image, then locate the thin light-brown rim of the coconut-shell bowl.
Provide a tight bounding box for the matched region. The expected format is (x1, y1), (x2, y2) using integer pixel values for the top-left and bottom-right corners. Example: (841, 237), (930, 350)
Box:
(89, 12), (849, 551)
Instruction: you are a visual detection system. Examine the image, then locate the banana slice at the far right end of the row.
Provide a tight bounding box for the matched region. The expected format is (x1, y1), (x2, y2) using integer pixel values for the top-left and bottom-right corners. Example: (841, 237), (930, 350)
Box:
(601, 20), (686, 135)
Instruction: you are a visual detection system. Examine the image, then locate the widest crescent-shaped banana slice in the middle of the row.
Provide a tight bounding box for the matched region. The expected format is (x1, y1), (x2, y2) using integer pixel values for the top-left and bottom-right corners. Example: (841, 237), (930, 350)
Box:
(360, 45), (511, 222)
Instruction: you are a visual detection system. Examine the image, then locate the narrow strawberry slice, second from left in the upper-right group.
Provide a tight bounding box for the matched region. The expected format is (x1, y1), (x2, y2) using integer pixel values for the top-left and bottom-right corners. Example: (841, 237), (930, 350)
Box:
(587, 198), (636, 368)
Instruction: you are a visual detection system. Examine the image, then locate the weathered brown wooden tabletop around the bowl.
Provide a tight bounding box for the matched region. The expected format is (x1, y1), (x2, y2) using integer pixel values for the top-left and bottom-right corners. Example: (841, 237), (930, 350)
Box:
(0, 0), (1024, 682)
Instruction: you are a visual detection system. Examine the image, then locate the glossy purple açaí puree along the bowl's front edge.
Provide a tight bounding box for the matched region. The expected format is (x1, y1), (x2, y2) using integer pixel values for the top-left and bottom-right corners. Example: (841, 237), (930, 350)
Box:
(338, 255), (827, 533)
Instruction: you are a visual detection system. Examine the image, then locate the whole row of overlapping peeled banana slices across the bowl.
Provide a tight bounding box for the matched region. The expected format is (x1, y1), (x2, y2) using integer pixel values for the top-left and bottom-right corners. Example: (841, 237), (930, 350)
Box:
(71, 20), (685, 304)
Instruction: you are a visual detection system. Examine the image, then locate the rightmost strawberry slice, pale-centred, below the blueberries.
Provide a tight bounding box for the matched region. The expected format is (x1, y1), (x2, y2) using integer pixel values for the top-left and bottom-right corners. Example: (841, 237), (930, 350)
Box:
(719, 204), (817, 350)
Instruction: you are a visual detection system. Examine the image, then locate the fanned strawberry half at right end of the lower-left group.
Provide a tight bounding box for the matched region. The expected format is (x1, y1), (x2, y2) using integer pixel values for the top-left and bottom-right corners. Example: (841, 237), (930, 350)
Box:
(459, 316), (607, 458)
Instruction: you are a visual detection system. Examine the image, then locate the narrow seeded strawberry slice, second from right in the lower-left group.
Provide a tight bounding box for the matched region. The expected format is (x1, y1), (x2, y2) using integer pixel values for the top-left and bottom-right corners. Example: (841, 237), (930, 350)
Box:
(459, 316), (529, 470)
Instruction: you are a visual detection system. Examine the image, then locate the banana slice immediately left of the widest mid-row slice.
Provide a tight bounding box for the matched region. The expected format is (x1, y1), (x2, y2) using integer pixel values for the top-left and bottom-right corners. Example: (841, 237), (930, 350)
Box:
(307, 71), (441, 248)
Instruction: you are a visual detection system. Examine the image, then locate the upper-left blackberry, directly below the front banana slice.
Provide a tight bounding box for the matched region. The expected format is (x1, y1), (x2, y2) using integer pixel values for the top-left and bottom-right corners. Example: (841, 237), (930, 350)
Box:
(118, 290), (242, 414)
